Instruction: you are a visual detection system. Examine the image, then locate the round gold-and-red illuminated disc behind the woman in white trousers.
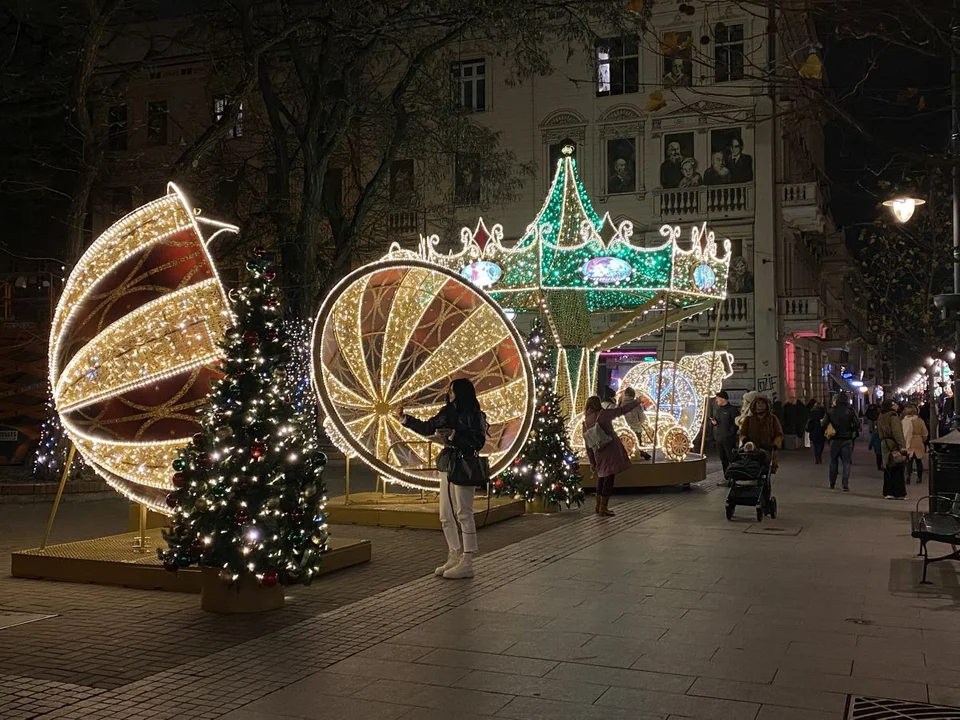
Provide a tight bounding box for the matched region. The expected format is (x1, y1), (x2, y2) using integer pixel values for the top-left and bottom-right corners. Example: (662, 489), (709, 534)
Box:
(313, 260), (534, 490)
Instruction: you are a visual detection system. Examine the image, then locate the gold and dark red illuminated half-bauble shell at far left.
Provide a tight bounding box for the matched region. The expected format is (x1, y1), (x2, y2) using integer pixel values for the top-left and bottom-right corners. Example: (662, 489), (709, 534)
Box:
(49, 184), (237, 514)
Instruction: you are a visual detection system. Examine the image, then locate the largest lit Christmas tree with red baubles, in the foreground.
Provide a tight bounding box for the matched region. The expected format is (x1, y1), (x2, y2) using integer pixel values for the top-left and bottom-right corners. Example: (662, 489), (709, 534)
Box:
(158, 249), (327, 587)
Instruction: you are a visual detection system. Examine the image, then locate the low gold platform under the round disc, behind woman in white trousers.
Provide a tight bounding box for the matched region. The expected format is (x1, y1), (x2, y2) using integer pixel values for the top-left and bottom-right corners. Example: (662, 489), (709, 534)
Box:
(327, 492), (524, 530)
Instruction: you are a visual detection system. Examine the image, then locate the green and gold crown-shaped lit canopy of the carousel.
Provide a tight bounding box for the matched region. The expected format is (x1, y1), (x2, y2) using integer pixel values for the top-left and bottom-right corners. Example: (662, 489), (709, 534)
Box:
(387, 141), (730, 349)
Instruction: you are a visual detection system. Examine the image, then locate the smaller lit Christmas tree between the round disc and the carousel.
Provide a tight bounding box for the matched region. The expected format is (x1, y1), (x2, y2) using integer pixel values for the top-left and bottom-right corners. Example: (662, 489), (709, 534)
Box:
(493, 320), (583, 507)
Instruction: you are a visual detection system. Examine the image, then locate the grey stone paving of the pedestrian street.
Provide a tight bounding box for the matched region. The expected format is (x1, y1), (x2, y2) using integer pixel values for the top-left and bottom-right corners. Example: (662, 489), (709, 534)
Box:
(0, 452), (960, 720)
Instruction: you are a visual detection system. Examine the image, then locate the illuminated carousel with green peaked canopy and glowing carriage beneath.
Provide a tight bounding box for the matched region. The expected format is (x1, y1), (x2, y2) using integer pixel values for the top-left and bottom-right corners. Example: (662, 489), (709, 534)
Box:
(387, 142), (732, 470)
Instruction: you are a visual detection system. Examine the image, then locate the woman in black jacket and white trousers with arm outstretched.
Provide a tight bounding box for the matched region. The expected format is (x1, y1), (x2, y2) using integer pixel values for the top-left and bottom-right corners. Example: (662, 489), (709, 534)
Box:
(400, 378), (489, 579)
